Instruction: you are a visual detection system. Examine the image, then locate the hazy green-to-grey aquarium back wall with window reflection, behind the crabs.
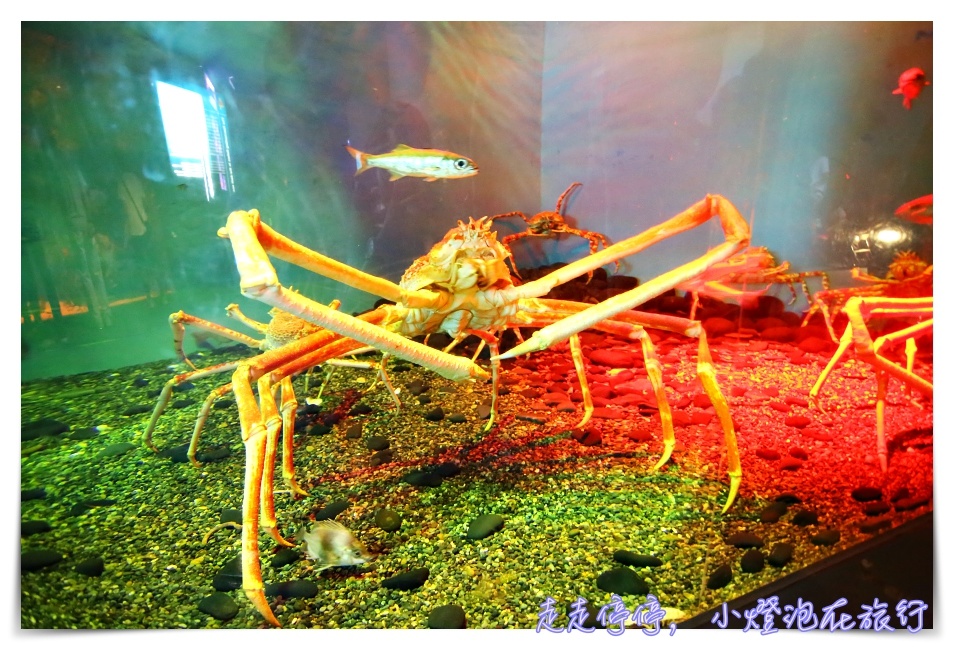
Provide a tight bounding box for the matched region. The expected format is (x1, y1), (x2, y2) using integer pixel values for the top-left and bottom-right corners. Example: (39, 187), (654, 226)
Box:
(21, 22), (933, 380)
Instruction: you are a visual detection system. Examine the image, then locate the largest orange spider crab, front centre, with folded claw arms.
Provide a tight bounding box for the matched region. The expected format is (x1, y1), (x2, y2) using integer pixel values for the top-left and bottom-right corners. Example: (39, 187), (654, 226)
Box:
(219, 195), (749, 626)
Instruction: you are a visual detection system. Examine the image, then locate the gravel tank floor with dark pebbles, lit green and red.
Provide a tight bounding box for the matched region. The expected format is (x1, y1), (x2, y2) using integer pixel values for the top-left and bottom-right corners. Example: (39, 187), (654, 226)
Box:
(20, 332), (933, 629)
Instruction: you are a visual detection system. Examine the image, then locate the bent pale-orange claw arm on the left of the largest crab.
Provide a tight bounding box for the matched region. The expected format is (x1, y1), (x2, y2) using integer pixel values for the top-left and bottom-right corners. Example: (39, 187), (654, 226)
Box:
(219, 210), (490, 381)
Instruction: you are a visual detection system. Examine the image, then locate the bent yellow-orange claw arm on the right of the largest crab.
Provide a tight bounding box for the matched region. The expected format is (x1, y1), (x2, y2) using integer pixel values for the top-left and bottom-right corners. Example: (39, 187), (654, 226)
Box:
(500, 195), (750, 359)
